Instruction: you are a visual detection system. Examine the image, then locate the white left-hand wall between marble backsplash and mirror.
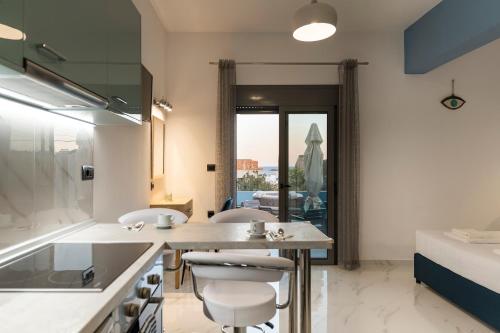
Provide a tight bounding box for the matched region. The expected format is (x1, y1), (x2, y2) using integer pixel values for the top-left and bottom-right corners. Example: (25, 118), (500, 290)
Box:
(94, 0), (166, 223)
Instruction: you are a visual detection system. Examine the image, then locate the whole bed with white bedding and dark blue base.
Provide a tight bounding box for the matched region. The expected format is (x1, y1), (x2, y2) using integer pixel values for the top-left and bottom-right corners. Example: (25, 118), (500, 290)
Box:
(414, 231), (500, 331)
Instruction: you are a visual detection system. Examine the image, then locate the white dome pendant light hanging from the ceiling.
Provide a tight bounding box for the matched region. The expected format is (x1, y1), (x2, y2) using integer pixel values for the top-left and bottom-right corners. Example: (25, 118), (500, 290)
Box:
(293, 0), (337, 42)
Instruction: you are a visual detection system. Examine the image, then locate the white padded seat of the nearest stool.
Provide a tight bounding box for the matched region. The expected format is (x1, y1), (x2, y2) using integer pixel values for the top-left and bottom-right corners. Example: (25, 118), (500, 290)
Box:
(203, 280), (276, 327)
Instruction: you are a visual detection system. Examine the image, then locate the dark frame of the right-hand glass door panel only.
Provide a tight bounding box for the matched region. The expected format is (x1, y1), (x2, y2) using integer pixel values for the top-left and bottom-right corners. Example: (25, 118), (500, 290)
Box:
(278, 105), (338, 265)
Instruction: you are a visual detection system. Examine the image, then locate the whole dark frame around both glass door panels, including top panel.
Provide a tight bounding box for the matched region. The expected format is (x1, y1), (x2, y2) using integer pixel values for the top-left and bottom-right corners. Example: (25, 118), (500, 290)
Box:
(235, 84), (339, 265)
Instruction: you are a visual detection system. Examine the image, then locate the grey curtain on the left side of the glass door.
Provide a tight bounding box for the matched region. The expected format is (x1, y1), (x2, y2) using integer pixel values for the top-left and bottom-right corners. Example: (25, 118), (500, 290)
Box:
(215, 59), (236, 210)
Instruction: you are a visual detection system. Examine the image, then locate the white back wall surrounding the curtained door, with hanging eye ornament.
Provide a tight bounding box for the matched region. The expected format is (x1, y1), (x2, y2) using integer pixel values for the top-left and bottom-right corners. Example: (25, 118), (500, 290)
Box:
(165, 33), (500, 259)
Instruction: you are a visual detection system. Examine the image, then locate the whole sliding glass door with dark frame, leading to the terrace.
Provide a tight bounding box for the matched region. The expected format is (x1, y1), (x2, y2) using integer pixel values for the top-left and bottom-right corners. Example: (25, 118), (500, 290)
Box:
(236, 86), (338, 264)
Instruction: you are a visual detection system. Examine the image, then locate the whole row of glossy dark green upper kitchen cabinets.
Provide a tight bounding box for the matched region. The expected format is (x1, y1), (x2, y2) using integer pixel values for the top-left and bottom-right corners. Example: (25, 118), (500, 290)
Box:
(0, 0), (142, 120)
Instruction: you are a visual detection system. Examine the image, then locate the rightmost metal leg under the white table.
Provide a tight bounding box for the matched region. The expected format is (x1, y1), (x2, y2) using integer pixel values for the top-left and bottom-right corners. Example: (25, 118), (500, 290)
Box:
(300, 249), (311, 333)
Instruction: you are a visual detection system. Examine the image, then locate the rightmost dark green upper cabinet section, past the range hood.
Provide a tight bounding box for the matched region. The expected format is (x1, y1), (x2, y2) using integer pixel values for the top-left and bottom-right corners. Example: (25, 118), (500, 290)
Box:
(106, 0), (142, 120)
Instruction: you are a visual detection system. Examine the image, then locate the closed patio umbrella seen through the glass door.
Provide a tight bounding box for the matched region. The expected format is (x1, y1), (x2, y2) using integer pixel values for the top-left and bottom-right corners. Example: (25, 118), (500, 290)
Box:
(304, 123), (323, 212)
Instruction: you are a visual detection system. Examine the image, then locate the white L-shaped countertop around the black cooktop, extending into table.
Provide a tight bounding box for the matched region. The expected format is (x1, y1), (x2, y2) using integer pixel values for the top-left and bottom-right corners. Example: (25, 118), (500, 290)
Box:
(0, 223), (333, 333)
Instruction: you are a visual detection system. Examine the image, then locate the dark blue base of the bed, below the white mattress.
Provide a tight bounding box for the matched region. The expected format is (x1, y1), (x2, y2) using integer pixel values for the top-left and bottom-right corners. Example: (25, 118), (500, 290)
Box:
(414, 253), (500, 332)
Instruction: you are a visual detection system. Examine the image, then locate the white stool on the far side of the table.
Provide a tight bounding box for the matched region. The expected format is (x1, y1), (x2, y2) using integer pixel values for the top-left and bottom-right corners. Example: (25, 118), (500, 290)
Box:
(210, 208), (279, 256)
